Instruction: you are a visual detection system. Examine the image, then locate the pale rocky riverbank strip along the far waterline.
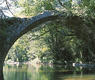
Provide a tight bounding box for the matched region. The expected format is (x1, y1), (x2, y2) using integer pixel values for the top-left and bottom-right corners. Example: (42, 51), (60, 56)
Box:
(5, 59), (95, 68)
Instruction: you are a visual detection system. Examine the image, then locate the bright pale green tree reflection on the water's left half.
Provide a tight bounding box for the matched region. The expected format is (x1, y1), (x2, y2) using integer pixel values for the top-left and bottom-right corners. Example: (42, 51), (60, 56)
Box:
(3, 65), (55, 80)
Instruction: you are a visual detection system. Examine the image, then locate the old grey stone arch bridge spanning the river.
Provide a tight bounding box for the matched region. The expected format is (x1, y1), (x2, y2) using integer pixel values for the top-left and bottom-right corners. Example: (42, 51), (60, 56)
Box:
(0, 11), (95, 80)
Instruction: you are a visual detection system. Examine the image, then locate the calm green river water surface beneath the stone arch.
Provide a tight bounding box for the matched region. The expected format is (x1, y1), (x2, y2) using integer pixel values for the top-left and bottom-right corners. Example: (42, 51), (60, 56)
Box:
(4, 65), (95, 80)
